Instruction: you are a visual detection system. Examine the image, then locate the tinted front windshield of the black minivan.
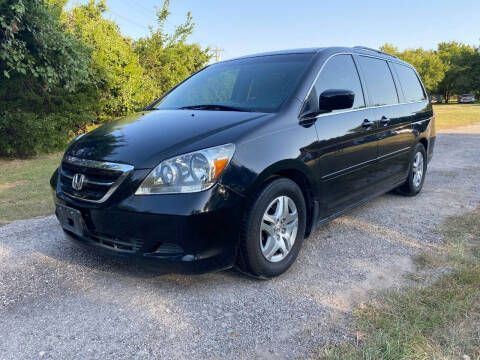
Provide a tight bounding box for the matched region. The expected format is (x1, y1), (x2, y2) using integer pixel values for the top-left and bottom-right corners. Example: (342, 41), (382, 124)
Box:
(154, 54), (313, 112)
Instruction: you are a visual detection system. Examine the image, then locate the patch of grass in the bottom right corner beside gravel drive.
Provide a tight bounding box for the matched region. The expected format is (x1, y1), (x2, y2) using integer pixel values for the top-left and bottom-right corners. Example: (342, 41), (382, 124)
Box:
(319, 208), (480, 360)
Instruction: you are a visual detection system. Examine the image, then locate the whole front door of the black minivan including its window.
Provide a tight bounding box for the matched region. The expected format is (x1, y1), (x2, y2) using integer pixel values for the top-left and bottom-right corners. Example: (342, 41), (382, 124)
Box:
(308, 54), (378, 217)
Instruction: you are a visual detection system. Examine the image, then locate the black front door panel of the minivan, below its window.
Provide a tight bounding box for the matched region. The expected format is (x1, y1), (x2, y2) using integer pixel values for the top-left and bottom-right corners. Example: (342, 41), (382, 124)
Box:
(315, 109), (378, 216)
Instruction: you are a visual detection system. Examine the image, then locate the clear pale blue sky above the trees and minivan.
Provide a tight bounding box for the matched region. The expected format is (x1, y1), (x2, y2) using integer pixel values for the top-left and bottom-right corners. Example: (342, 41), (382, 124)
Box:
(69, 0), (480, 60)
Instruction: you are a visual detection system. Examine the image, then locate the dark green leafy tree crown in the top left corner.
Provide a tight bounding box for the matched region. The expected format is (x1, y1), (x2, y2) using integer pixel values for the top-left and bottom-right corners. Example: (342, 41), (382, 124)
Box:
(0, 0), (90, 91)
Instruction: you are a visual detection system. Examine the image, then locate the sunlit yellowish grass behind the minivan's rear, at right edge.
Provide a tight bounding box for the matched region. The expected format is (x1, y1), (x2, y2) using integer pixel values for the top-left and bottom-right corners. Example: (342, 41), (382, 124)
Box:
(433, 104), (480, 130)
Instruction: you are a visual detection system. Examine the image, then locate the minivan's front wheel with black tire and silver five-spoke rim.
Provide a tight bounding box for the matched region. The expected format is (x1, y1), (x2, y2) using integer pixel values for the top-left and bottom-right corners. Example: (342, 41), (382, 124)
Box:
(236, 178), (307, 279)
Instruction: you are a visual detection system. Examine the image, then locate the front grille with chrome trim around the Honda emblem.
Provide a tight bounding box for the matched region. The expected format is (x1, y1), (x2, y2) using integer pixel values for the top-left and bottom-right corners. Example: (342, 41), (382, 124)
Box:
(59, 156), (133, 203)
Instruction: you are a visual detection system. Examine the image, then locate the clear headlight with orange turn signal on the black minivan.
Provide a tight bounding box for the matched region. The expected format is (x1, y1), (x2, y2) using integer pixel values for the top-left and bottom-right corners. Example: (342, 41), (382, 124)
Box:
(135, 144), (235, 195)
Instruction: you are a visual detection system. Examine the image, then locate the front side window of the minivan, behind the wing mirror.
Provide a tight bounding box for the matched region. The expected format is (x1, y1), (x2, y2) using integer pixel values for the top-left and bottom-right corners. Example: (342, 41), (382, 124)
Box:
(304, 55), (365, 111)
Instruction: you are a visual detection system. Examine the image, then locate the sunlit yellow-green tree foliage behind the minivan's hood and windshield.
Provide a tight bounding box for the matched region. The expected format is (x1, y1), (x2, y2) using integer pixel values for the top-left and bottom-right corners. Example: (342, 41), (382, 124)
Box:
(66, 0), (210, 122)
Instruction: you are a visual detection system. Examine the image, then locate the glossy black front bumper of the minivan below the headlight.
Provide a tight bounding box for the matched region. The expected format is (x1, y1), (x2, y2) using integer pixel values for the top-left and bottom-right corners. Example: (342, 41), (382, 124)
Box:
(52, 179), (243, 274)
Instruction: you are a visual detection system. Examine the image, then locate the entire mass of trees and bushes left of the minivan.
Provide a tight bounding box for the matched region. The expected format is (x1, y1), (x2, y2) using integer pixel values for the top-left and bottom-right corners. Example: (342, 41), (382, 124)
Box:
(0, 0), (210, 156)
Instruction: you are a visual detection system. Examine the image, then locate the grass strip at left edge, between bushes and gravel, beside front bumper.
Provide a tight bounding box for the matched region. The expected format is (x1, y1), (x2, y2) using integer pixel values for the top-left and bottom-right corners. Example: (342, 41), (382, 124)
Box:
(0, 153), (62, 226)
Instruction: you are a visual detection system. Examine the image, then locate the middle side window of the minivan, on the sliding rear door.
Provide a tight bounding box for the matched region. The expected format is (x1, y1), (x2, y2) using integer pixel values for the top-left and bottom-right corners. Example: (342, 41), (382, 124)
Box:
(358, 56), (398, 106)
